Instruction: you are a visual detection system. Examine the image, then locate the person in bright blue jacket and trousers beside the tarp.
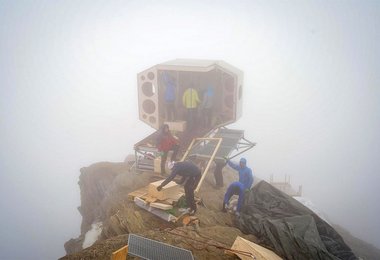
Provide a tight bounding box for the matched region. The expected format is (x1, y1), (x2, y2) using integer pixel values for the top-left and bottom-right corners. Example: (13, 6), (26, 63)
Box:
(222, 158), (253, 213)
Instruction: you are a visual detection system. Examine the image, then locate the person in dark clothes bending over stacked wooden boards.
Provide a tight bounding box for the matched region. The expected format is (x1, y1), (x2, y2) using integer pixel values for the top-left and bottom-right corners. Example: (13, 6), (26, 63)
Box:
(157, 161), (202, 214)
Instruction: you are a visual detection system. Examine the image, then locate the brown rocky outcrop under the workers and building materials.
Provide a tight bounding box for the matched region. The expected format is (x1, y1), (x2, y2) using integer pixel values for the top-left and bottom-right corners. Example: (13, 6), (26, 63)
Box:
(61, 161), (380, 260)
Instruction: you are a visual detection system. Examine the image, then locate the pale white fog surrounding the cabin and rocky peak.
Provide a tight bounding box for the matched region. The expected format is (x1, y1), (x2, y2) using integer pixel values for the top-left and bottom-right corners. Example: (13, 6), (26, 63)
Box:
(0, 1), (380, 259)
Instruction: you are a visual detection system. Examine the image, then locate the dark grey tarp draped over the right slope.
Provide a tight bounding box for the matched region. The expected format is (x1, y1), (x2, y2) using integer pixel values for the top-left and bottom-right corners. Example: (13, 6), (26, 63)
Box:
(238, 181), (358, 260)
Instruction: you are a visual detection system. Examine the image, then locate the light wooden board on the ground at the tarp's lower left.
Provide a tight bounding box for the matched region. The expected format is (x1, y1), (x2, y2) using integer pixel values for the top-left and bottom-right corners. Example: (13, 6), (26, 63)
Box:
(231, 236), (282, 260)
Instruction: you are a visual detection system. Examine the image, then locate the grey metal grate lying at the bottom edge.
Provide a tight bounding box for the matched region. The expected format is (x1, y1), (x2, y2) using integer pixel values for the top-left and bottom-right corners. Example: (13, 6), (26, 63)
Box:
(128, 234), (194, 260)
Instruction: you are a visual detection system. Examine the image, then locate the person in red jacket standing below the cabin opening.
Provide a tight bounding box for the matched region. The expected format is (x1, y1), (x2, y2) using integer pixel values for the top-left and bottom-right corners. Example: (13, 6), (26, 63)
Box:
(157, 124), (179, 175)
